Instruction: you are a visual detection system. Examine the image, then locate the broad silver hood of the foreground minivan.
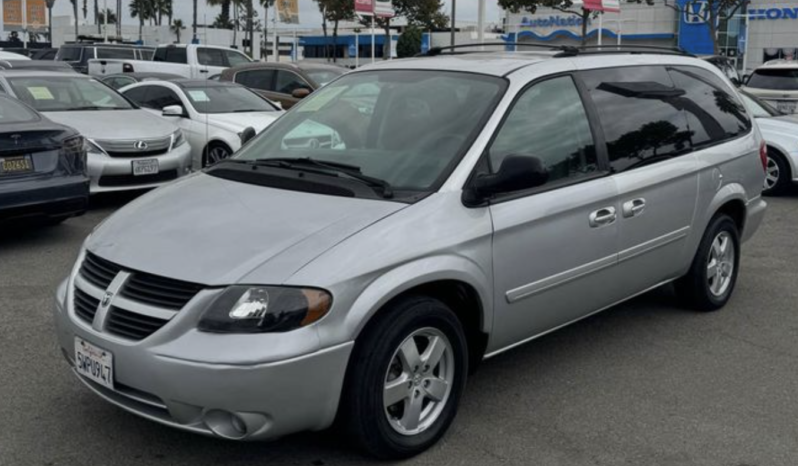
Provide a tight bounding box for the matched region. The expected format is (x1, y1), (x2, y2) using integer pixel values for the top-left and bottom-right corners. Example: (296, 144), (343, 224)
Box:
(86, 173), (406, 286)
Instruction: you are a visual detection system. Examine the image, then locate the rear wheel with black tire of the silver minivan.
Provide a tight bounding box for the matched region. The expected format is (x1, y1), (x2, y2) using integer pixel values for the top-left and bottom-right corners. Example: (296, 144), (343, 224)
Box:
(676, 214), (740, 312)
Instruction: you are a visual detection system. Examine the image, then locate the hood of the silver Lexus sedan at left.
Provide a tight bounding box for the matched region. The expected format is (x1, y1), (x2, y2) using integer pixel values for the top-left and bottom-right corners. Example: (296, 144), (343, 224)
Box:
(44, 110), (177, 141)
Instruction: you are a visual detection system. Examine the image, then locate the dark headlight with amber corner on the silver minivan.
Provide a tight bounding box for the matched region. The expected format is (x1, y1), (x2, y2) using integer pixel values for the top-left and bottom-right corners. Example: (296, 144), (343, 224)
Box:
(198, 286), (332, 333)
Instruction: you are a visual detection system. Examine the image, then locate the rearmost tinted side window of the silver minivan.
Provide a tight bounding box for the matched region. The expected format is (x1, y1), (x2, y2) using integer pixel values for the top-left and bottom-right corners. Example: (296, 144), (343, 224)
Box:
(669, 66), (751, 146)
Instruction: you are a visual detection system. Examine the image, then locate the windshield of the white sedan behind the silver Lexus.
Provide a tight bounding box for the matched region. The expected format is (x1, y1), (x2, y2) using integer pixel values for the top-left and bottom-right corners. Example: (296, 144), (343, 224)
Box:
(186, 85), (276, 114)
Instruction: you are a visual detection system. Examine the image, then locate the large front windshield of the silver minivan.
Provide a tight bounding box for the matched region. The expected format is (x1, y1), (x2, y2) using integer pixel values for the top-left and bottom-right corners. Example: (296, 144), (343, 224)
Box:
(231, 70), (505, 192)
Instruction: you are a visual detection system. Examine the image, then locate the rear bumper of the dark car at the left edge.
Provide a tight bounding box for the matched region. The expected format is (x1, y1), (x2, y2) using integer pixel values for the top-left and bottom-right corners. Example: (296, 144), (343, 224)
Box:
(0, 175), (89, 220)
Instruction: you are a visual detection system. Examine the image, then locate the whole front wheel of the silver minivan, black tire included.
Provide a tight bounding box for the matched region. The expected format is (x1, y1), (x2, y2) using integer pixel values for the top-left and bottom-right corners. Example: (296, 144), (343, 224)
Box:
(341, 297), (468, 459)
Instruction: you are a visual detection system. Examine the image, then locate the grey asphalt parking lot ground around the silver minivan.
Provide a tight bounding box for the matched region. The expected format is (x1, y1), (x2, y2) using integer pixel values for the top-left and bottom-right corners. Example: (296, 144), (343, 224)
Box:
(0, 190), (798, 466)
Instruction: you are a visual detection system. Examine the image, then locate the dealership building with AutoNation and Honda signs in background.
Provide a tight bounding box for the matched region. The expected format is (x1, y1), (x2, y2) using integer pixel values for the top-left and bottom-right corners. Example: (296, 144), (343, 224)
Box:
(503, 0), (798, 71)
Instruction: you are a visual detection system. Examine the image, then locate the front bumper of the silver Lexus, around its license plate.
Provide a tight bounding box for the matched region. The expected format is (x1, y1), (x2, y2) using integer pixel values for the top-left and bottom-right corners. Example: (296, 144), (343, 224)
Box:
(88, 143), (191, 194)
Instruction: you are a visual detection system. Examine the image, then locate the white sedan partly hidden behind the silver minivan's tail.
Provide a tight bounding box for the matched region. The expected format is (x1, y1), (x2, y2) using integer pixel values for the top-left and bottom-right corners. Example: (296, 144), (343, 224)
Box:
(740, 91), (798, 194)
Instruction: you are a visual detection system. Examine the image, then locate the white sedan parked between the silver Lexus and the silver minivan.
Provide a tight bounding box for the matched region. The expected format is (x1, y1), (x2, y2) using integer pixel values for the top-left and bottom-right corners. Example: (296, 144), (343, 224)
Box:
(119, 79), (284, 170)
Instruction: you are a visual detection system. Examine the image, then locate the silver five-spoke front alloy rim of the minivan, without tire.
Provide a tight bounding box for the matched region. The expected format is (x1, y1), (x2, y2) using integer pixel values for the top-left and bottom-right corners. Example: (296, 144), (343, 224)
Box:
(383, 327), (455, 436)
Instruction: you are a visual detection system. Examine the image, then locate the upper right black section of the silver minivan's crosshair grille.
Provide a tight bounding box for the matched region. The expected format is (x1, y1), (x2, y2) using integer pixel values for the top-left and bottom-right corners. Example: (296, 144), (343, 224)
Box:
(122, 272), (202, 310)
